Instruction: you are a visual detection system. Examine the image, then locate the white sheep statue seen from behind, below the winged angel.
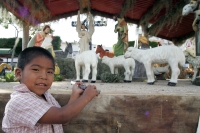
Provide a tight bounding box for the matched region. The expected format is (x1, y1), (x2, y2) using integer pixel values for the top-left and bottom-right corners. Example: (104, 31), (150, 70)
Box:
(75, 50), (98, 83)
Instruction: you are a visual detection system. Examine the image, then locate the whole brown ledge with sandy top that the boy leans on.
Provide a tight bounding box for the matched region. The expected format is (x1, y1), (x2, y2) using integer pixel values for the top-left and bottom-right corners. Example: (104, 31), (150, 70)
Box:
(0, 81), (200, 133)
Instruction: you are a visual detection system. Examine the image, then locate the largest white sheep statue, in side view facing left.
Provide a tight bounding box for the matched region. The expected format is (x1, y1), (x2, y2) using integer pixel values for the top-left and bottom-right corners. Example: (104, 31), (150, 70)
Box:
(124, 45), (185, 86)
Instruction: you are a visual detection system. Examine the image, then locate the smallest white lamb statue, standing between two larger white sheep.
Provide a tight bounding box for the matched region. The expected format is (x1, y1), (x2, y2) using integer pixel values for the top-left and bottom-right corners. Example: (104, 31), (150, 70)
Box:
(102, 55), (135, 82)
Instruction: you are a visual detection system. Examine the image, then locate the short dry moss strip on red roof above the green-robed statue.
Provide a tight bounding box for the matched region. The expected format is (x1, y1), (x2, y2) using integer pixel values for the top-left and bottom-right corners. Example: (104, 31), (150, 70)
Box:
(119, 0), (137, 17)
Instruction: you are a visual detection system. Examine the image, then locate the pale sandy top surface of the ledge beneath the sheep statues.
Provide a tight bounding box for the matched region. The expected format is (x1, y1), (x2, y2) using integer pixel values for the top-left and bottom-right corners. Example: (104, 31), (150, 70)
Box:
(0, 80), (200, 95)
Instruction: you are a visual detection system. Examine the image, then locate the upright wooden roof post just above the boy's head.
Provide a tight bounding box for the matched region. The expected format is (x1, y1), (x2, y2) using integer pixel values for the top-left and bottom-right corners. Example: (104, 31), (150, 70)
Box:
(22, 22), (29, 50)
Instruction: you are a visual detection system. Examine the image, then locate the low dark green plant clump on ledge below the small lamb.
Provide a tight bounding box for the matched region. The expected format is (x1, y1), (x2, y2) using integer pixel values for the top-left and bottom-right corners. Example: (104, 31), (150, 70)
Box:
(101, 72), (123, 83)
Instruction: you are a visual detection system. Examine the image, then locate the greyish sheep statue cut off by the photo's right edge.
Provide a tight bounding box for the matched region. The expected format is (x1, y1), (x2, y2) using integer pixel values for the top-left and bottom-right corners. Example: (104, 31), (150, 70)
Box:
(184, 47), (200, 82)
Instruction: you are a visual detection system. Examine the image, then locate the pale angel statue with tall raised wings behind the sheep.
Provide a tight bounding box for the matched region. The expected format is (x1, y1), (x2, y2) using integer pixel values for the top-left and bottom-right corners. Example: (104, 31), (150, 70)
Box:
(76, 11), (94, 53)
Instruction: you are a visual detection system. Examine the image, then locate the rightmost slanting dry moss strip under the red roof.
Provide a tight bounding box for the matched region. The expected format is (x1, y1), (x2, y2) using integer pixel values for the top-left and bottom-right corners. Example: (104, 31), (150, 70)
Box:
(148, 0), (187, 35)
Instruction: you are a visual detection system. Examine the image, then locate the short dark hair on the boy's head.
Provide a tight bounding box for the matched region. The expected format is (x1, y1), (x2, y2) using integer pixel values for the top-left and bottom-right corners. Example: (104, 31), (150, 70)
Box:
(17, 47), (55, 70)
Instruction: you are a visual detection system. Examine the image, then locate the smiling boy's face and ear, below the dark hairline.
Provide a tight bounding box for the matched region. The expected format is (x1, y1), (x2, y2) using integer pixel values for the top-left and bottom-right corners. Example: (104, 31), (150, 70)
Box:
(15, 57), (54, 96)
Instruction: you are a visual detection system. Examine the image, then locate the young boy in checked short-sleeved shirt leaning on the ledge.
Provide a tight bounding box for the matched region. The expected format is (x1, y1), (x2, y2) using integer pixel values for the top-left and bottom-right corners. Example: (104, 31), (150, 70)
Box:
(2, 47), (98, 133)
